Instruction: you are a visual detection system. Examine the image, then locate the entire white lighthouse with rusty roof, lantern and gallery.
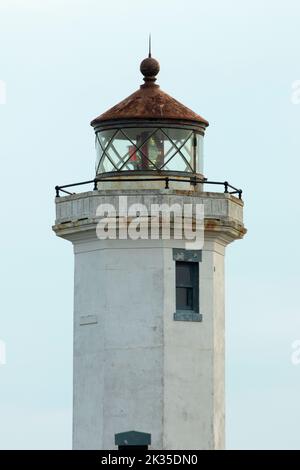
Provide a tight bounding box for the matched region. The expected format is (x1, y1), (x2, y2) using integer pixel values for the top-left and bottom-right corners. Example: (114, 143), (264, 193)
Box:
(53, 49), (246, 450)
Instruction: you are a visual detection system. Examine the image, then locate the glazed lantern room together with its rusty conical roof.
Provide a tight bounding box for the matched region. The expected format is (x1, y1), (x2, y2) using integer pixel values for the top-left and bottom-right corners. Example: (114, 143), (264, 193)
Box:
(91, 53), (208, 179)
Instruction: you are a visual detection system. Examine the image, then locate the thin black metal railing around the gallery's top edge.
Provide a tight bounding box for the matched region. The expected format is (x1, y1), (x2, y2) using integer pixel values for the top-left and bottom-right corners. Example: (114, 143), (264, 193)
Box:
(55, 176), (243, 199)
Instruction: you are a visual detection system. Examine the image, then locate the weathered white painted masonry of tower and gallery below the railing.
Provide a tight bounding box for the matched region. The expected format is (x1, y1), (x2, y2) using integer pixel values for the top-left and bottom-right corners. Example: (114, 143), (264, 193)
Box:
(54, 190), (243, 449)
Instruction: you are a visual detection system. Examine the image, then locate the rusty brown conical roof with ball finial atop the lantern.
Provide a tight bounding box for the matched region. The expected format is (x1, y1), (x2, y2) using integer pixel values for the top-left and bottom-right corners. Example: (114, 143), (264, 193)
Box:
(91, 56), (209, 127)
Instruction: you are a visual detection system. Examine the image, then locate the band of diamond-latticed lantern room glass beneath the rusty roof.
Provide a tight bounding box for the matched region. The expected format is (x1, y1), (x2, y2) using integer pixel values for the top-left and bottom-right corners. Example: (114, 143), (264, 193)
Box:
(96, 128), (203, 174)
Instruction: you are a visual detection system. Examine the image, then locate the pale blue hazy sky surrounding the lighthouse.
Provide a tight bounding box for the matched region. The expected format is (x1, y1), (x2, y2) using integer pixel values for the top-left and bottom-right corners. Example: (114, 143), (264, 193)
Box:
(0, 0), (300, 449)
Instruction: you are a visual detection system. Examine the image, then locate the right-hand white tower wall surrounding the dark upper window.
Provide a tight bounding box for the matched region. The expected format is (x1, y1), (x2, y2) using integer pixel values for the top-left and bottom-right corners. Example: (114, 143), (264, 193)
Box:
(164, 240), (224, 449)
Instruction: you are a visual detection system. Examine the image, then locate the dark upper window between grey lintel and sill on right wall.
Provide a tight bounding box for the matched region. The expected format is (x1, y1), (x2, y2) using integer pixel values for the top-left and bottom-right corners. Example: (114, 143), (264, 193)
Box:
(176, 261), (199, 312)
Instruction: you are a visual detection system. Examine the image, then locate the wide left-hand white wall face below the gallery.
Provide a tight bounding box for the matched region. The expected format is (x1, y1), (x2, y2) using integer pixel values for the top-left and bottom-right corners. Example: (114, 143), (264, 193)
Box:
(73, 240), (164, 449)
